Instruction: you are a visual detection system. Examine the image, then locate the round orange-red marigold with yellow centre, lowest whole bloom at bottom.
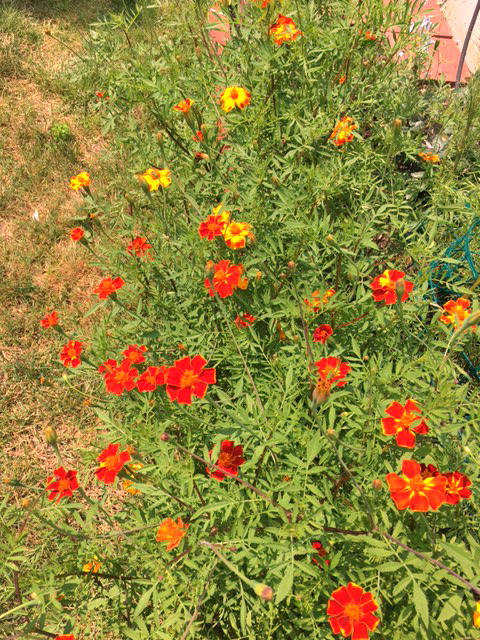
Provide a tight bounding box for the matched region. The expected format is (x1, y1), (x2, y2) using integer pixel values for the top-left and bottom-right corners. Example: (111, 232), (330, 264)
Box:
(327, 582), (380, 640)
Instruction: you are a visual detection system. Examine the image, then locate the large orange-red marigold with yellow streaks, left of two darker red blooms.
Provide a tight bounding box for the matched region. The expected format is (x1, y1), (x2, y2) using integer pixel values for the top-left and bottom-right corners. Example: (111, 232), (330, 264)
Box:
(386, 460), (447, 511)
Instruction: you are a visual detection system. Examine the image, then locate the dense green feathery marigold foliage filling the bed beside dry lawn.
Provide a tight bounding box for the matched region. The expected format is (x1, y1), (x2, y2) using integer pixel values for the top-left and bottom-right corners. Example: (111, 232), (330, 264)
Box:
(0, 0), (480, 640)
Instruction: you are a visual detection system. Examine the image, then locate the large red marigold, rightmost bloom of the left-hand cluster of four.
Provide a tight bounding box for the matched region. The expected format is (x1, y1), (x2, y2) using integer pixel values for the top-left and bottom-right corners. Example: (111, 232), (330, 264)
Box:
(166, 356), (217, 404)
